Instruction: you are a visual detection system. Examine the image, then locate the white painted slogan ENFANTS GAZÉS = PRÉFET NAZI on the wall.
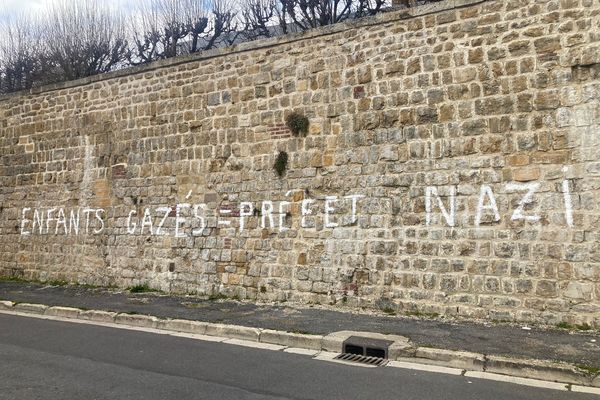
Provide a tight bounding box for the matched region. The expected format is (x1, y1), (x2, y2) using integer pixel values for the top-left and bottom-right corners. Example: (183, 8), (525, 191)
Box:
(20, 183), (574, 238)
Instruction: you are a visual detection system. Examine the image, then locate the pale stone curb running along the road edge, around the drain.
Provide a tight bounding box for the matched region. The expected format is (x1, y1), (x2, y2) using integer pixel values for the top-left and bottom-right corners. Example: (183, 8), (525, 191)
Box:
(0, 301), (600, 393)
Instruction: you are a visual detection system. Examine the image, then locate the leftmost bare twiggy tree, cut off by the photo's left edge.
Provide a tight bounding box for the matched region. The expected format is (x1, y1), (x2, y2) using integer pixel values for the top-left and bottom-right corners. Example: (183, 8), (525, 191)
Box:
(0, 15), (45, 93)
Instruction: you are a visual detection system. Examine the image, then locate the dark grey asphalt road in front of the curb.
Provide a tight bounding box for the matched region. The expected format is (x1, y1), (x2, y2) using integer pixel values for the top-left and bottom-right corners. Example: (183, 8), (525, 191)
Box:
(0, 314), (597, 400)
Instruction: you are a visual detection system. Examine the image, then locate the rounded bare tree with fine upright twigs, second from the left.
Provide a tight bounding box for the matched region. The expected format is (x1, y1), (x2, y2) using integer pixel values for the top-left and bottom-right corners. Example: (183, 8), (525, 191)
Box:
(43, 0), (127, 80)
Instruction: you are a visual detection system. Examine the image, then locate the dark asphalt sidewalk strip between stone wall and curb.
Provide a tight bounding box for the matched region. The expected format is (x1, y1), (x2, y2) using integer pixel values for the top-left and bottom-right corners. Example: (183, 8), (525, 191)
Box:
(0, 282), (600, 367)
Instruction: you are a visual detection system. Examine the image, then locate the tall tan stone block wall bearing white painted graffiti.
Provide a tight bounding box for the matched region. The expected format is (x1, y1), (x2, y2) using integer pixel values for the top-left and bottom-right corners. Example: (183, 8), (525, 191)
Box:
(0, 0), (600, 327)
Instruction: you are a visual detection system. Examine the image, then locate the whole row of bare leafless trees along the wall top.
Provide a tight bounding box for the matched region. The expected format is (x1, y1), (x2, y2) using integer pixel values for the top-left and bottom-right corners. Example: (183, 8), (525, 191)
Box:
(0, 0), (440, 92)
